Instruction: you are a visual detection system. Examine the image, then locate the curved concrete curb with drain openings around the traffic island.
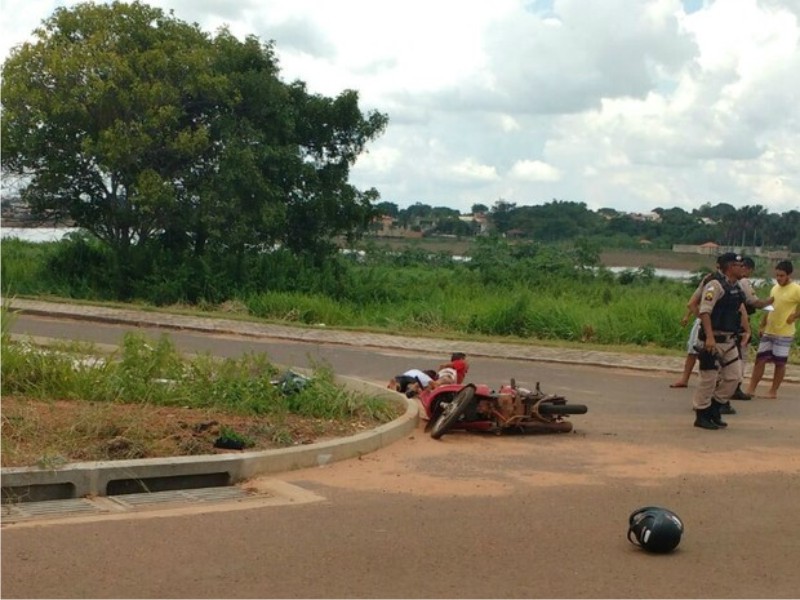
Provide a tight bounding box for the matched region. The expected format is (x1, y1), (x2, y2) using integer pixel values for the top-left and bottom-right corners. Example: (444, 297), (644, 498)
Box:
(2, 376), (419, 502)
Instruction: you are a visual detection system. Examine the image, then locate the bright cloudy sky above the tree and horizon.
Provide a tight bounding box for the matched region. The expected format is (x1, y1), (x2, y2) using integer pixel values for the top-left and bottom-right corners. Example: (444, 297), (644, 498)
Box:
(0, 0), (800, 213)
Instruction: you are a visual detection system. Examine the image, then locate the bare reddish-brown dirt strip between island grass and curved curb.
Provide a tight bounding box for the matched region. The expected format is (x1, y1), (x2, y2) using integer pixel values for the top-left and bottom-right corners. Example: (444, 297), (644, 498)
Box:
(2, 396), (388, 467)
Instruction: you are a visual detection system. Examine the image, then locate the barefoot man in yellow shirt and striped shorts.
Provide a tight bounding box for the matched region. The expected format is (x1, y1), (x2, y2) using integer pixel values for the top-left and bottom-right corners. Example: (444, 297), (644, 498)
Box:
(747, 260), (800, 398)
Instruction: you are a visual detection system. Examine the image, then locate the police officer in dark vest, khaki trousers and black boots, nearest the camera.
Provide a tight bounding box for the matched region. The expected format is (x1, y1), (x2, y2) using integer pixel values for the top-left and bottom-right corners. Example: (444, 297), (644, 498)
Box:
(692, 252), (747, 430)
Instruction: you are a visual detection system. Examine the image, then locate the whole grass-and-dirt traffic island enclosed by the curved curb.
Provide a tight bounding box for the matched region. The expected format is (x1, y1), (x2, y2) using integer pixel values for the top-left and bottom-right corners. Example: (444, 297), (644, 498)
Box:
(0, 311), (402, 468)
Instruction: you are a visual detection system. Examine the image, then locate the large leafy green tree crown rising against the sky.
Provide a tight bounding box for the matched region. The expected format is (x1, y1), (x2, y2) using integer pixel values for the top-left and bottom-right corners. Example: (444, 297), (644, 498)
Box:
(2, 2), (387, 292)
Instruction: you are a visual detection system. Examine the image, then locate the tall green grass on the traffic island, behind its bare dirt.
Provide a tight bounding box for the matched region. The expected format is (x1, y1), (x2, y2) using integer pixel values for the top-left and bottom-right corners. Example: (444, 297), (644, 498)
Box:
(0, 333), (395, 422)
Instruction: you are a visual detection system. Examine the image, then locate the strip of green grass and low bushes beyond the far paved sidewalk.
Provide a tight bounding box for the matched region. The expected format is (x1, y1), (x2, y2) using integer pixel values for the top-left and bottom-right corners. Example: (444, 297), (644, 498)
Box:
(2, 237), (792, 352)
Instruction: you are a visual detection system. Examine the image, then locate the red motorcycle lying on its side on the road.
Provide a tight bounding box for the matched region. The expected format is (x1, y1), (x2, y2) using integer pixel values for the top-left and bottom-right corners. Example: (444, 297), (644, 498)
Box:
(417, 379), (588, 439)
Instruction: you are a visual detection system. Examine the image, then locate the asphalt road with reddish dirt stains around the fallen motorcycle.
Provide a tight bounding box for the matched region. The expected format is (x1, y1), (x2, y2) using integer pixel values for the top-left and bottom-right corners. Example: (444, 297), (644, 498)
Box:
(2, 316), (800, 598)
